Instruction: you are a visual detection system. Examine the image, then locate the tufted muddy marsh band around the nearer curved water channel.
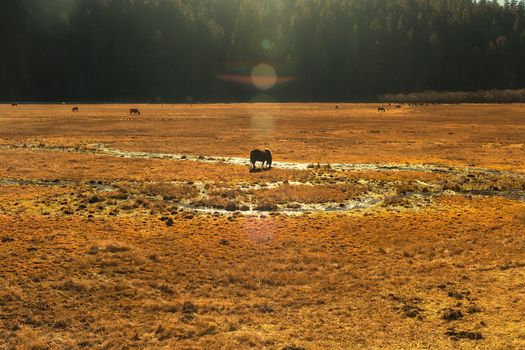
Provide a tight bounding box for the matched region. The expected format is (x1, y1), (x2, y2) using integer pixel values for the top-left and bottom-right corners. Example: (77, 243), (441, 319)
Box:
(0, 175), (525, 222)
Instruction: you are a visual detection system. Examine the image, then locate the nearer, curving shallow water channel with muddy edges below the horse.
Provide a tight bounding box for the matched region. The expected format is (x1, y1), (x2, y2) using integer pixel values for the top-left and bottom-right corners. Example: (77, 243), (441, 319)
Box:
(0, 175), (525, 216)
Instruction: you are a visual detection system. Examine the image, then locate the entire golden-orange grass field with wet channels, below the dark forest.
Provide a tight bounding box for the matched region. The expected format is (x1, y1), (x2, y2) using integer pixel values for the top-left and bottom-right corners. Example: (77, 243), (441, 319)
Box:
(0, 103), (525, 350)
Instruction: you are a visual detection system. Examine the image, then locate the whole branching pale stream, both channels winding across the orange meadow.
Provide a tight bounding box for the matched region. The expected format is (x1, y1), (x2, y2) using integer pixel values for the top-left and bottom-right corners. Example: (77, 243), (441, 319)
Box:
(0, 144), (525, 216)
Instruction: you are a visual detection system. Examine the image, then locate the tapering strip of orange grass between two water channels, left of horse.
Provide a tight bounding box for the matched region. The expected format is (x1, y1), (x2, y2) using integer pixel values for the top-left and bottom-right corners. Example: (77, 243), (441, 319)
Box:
(0, 149), (310, 182)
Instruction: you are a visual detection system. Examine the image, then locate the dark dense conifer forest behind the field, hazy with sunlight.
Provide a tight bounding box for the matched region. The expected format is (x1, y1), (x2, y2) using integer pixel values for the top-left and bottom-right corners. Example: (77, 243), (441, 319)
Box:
(0, 0), (525, 101)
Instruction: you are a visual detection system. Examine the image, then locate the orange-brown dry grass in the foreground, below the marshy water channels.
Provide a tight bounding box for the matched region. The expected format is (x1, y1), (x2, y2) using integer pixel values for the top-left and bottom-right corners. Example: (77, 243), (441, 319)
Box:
(0, 196), (525, 349)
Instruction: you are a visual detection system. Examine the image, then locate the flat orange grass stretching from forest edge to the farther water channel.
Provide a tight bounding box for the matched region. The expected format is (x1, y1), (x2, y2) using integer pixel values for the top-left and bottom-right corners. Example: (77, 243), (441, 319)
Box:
(0, 103), (525, 171)
